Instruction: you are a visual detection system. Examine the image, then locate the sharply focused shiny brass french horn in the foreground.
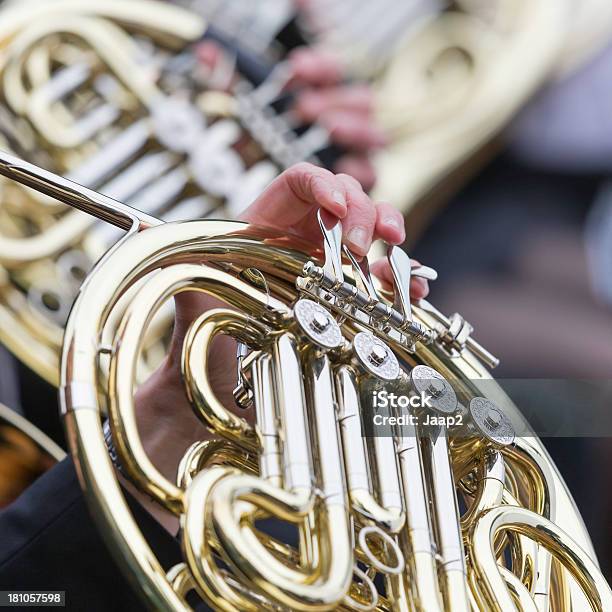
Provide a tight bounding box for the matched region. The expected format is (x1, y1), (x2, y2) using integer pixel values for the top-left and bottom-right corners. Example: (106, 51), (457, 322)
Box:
(0, 153), (612, 611)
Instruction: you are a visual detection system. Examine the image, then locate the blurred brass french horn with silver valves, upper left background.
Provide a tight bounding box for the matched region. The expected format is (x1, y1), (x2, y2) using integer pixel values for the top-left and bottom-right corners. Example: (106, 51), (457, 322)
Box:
(0, 0), (328, 385)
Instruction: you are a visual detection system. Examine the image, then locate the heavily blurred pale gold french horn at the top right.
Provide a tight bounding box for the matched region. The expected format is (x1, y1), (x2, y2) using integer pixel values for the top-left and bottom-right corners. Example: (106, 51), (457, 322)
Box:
(298, 0), (572, 232)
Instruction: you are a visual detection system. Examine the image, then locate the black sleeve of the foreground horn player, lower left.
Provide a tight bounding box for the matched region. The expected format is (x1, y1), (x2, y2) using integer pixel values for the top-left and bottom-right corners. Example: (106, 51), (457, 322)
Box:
(0, 459), (181, 612)
